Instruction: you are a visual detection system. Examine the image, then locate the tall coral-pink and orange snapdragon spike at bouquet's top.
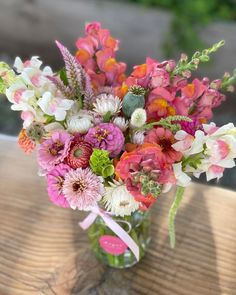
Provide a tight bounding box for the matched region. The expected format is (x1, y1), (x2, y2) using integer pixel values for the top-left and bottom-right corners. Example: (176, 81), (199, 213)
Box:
(76, 22), (126, 89)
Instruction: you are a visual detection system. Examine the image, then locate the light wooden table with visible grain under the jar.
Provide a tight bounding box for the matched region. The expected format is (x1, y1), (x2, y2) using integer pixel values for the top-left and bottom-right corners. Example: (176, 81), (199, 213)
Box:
(0, 140), (236, 295)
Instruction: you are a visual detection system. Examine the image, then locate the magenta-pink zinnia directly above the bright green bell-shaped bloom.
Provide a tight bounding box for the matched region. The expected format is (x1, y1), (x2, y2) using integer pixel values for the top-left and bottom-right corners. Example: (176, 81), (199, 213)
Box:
(84, 123), (125, 158)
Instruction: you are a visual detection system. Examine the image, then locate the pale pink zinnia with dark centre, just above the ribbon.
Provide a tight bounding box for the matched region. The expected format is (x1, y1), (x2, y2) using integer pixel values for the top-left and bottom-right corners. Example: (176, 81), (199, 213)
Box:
(62, 168), (104, 211)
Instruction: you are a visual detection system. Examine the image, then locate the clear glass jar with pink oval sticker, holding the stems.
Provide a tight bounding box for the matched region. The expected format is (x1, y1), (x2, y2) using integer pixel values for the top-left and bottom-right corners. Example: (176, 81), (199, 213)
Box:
(88, 210), (151, 268)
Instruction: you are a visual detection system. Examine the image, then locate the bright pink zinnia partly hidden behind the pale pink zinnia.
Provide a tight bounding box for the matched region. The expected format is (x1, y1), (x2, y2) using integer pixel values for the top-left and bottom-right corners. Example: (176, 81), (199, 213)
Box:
(47, 164), (71, 208)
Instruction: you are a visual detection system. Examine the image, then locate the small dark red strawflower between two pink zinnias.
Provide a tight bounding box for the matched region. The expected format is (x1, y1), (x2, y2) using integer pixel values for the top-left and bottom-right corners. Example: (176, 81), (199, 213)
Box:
(66, 140), (93, 169)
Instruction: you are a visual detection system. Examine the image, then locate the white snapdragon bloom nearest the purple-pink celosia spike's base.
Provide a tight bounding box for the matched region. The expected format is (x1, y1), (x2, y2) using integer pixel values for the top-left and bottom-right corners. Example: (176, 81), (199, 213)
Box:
(38, 92), (74, 121)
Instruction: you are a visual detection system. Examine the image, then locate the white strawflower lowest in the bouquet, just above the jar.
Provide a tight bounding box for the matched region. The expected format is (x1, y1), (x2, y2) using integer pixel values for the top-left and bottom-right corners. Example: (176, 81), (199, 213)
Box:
(103, 181), (139, 217)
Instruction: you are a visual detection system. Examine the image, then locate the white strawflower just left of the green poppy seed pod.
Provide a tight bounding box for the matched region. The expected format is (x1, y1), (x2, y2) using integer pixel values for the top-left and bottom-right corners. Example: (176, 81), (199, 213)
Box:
(93, 94), (121, 116)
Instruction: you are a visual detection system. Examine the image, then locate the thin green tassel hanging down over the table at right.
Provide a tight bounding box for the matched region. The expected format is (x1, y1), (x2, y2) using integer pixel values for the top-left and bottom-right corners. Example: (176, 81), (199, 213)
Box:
(168, 186), (184, 248)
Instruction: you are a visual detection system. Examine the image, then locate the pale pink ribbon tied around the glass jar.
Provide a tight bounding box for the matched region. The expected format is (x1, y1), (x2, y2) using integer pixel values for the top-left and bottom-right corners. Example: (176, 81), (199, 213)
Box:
(79, 206), (139, 260)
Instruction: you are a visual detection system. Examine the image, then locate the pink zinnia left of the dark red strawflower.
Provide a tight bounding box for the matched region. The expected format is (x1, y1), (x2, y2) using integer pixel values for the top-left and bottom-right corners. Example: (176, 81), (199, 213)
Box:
(38, 131), (73, 171)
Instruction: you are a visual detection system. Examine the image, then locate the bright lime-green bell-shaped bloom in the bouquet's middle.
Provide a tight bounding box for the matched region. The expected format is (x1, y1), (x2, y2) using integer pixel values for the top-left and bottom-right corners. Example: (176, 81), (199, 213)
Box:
(90, 149), (115, 178)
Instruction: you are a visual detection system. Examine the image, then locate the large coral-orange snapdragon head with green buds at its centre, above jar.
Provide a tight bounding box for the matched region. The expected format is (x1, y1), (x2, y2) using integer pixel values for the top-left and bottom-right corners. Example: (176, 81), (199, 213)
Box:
(116, 143), (175, 208)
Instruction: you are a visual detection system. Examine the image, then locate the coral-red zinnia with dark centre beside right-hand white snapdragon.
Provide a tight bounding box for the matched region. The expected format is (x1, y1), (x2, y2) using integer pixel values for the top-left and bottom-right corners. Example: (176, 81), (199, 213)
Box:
(144, 127), (182, 163)
